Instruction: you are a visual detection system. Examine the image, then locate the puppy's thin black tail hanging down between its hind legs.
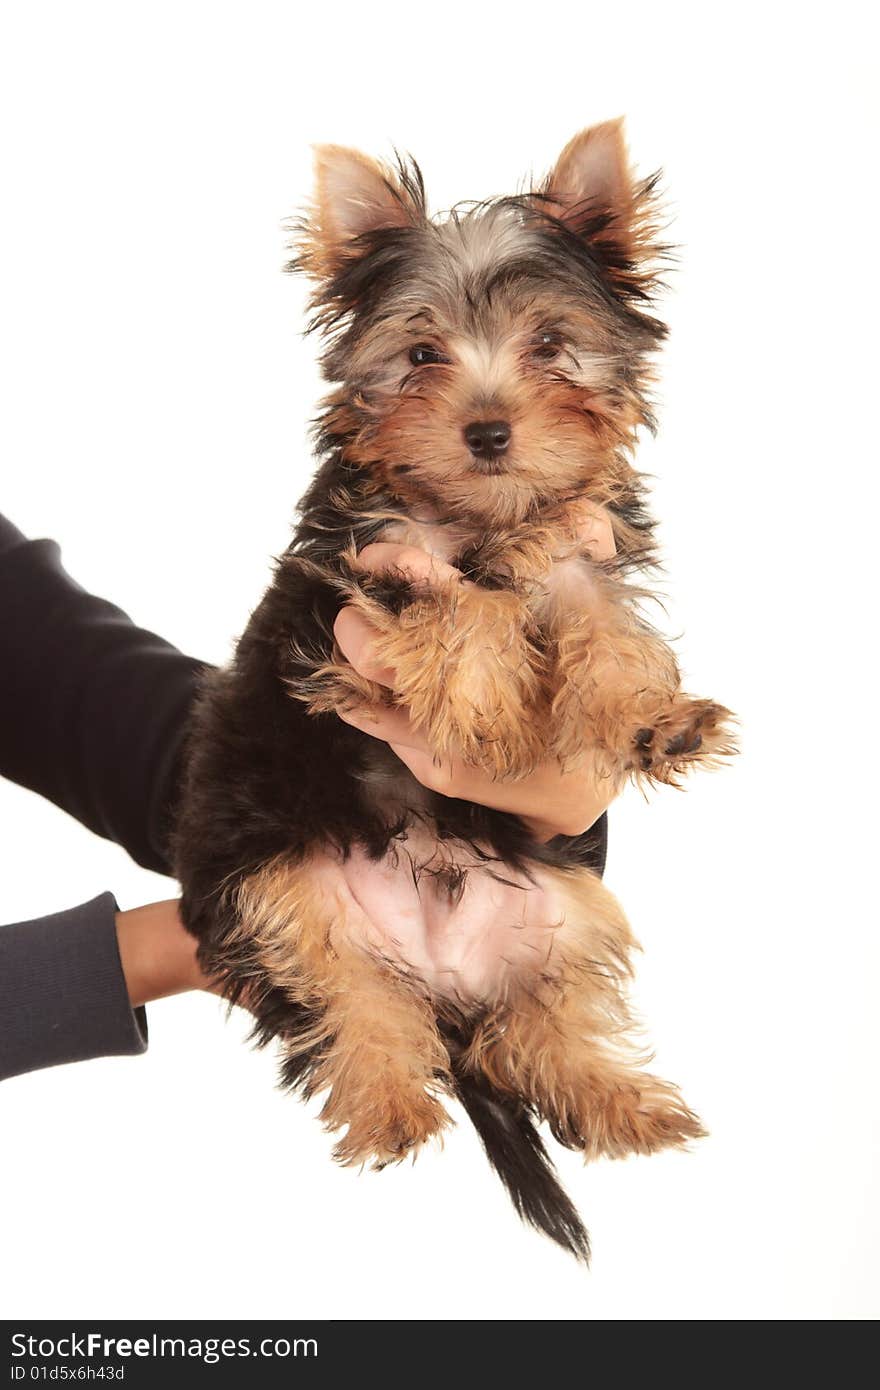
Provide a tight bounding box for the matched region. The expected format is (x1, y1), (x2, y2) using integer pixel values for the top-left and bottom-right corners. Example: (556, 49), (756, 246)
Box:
(456, 1073), (589, 1265)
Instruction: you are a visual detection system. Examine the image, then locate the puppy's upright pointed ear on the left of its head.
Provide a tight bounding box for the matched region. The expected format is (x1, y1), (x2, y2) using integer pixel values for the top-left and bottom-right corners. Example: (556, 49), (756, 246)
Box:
(296, 145), (425, 279)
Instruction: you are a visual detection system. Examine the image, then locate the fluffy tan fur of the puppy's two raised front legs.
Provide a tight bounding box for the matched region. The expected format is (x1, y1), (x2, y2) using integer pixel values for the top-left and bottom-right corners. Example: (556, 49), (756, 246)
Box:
(295, 503), (737, 784)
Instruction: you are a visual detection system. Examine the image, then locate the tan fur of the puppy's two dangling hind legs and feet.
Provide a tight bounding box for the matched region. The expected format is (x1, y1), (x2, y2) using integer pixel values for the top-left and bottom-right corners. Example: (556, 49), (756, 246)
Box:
(238, 860), (703, 1166)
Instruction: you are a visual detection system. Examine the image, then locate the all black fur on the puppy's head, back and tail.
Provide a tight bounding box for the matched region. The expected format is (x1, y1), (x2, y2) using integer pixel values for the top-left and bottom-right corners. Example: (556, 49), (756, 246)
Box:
(169, 152), (653, 1259)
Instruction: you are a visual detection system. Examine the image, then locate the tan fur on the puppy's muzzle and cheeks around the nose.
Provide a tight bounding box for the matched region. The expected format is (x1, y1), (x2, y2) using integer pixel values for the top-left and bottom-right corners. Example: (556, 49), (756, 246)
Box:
(349, 319), (642, 530)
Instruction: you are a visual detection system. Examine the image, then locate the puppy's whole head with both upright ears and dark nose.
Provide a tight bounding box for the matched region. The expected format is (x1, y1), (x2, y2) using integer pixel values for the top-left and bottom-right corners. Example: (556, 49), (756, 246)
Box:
(292, 122), (663, 525)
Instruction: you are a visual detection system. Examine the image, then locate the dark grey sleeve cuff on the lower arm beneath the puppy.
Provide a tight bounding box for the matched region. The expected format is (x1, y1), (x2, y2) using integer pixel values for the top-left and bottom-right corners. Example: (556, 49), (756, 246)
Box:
(0, 892), (147, 1080)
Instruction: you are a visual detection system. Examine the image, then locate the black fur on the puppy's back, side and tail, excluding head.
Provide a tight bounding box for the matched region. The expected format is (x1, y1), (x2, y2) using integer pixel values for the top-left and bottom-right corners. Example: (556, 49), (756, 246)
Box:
(175, 456), (606, 1258)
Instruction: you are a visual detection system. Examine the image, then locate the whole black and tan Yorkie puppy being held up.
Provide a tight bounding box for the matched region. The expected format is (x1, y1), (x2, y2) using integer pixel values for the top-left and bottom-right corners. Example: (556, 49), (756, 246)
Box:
(177, 121), (735, 1258)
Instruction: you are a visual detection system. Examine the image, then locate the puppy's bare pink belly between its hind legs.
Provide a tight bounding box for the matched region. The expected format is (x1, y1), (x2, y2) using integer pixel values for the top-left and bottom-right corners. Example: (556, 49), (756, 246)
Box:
(310, 828), (566, 1002)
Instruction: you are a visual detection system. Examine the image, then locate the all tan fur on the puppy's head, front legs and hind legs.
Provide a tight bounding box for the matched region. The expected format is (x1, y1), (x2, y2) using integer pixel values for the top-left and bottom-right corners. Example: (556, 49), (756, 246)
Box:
(262, 121), (735, 1195)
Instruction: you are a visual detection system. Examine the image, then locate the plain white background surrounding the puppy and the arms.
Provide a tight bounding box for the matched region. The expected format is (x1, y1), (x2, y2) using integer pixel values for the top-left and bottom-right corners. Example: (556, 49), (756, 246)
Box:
(0, 0), (880, 1319)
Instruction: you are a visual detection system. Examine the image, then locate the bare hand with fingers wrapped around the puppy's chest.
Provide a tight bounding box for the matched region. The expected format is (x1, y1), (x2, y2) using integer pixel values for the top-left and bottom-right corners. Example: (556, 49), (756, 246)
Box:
(334, 507), (620, 841)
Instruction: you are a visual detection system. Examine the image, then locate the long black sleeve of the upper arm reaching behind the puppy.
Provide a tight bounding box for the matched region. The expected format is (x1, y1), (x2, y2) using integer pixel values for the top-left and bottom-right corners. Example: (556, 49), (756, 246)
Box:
(0, 517), (204, 873)
